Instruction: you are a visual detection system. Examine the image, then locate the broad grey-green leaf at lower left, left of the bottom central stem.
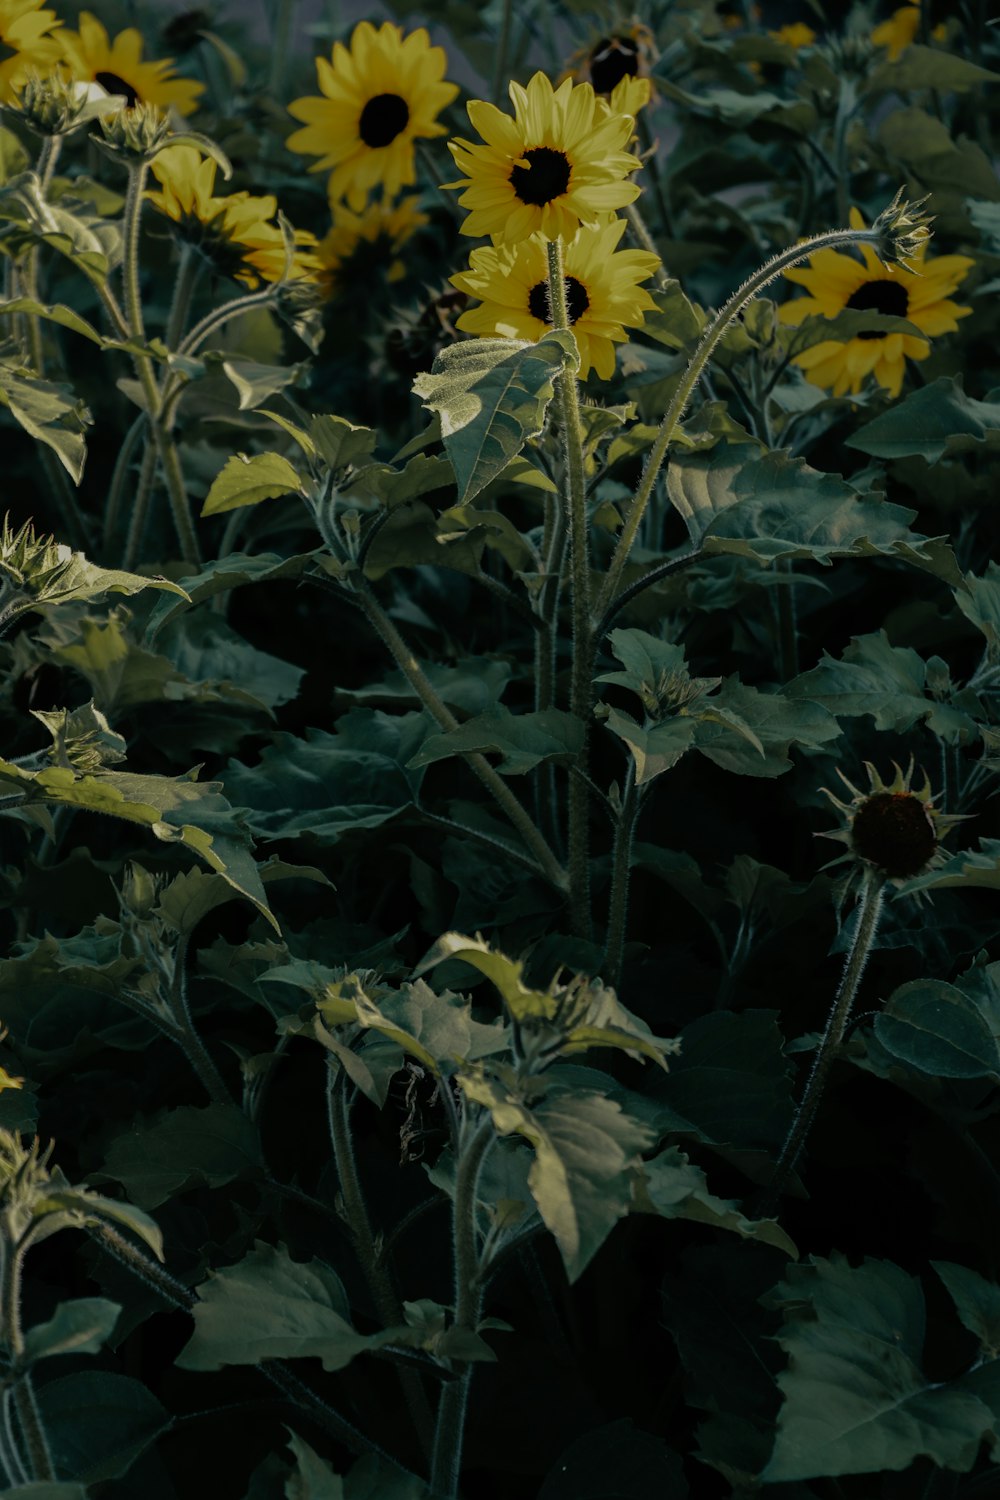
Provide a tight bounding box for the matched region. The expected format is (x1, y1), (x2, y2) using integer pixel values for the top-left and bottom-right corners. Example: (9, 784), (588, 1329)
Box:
(177, 1241), (408, 1371)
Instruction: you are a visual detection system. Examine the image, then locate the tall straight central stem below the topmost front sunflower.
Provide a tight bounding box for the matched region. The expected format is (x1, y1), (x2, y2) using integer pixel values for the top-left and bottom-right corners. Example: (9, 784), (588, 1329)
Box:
(546, 240), (594, 938)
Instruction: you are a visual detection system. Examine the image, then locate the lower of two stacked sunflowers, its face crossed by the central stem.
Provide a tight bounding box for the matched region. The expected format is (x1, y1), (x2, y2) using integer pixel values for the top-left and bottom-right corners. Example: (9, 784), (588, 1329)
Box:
(451, 219), (660, 380)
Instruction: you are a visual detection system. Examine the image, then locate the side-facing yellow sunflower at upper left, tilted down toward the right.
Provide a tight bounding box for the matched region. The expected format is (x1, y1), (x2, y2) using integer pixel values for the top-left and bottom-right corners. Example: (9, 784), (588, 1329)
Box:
(145, 146), (321, 288)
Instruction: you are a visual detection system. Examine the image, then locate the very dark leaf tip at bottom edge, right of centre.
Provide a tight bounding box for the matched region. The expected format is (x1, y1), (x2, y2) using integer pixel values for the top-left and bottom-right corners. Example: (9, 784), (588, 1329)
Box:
(538, 1418), (690, 1500)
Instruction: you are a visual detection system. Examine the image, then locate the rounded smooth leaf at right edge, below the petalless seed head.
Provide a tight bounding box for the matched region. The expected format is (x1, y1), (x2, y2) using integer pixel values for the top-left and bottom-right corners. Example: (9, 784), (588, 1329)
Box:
(874, 980), (1000, 1083)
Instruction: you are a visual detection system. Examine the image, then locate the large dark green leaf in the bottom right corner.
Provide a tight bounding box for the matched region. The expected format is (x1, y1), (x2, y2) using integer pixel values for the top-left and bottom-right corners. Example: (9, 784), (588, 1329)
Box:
(762, 1256), (993, 1484)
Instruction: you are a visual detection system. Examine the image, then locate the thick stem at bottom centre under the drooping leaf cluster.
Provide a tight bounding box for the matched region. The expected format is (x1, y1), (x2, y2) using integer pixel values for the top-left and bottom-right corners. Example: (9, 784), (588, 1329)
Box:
(430, 1115), (495, 1500)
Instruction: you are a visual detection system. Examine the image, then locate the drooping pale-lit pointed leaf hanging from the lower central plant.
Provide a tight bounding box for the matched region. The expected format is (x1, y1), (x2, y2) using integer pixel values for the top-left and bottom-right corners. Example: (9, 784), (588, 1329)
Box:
(459, 1074), (655, 1281)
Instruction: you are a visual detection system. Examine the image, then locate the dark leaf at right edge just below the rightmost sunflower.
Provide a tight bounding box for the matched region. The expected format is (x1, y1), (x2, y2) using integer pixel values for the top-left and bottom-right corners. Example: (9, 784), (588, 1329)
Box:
(846, 375), (1000, 464)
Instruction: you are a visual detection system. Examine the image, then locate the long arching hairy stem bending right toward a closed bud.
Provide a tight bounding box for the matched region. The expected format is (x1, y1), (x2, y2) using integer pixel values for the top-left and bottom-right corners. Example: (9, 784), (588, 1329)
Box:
(598, 220), (879, 618)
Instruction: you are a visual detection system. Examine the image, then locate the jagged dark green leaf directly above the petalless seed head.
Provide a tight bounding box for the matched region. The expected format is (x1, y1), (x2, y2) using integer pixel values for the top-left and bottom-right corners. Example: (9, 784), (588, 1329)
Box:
(786, 630), (978, 744)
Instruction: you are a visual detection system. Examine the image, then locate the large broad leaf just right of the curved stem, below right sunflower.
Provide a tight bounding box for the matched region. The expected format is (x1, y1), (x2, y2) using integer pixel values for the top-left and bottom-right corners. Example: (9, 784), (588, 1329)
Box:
(667, 440), (933, 564)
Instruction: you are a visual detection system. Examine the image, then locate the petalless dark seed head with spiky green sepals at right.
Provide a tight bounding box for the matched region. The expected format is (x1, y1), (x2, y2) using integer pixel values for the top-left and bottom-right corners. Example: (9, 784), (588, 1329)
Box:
(822, 759), (964, 887)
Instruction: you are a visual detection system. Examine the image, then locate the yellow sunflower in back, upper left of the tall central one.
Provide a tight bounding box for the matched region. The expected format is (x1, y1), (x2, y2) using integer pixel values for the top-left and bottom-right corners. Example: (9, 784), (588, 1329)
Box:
(286, 21), (459, 213)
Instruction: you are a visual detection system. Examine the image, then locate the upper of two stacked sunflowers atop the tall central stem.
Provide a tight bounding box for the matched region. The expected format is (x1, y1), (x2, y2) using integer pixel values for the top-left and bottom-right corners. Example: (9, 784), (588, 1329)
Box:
(445, 74), (639, 243)
